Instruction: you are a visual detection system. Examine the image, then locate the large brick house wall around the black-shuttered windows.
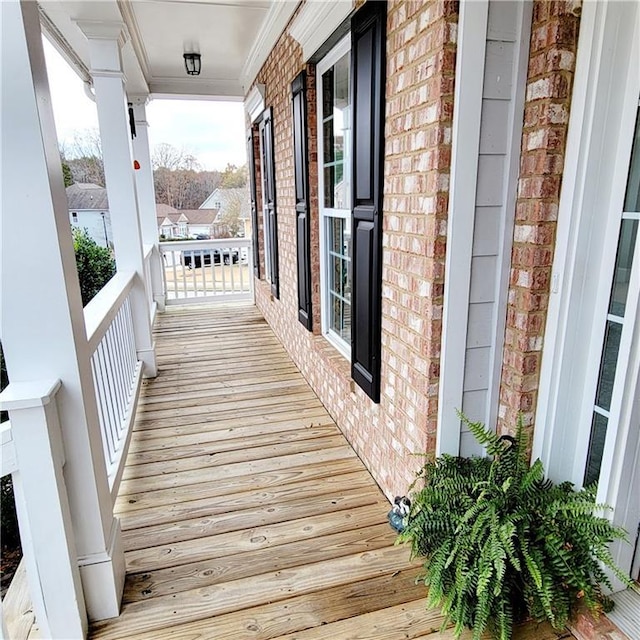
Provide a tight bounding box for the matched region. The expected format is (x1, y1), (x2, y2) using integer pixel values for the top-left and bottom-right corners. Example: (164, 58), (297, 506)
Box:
(256, 0), (457, 496)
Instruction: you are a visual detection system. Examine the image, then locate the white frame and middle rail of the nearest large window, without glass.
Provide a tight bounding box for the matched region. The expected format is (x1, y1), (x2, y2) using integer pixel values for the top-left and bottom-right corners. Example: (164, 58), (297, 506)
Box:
(316, 35), (353, 360)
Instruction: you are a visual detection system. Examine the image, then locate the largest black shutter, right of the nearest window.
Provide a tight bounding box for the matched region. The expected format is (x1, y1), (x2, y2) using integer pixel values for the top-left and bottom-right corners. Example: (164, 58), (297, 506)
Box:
(351, 2), (387, 402)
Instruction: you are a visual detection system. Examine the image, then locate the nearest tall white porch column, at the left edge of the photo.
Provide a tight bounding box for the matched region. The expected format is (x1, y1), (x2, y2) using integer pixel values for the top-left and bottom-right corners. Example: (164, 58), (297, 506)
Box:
(0, 0), (125, 619)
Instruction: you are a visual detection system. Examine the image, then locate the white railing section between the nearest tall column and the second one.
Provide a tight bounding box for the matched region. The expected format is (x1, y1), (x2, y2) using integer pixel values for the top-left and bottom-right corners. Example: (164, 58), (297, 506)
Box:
(84, 272), (142, 499)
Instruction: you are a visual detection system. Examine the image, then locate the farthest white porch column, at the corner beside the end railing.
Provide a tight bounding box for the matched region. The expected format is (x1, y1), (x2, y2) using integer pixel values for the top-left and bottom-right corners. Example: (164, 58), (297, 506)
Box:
(129, 95), (165, 311)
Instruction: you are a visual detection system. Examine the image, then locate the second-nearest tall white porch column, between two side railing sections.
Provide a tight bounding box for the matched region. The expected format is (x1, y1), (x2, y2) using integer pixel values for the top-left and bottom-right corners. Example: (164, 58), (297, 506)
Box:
(78, 21), (157, 377)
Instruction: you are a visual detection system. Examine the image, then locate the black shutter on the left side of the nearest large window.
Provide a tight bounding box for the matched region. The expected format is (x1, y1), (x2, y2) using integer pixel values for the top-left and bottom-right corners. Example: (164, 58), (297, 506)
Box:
(291, 71), (312, 330)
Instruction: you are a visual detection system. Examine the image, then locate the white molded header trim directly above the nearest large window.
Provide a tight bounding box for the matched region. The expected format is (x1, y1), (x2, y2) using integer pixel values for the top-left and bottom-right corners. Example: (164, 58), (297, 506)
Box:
(289, 0), (355, 62)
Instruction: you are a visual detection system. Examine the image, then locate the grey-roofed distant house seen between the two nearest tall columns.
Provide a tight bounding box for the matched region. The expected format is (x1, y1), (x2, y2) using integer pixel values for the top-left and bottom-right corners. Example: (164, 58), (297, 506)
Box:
(67, 183), (113, 247)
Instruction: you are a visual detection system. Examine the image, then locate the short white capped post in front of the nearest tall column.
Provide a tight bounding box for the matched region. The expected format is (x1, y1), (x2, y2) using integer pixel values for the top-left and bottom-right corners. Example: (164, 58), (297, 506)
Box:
(0, 380), (88, 640)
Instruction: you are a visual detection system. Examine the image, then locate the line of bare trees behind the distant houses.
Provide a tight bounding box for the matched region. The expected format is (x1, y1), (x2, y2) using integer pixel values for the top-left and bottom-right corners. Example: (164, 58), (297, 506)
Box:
(60, 129), (247, 209)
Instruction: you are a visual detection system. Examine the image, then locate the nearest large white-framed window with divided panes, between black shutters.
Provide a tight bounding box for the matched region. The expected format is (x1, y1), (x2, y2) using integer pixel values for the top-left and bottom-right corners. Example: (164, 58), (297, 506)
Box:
(316, 37), (352, 357)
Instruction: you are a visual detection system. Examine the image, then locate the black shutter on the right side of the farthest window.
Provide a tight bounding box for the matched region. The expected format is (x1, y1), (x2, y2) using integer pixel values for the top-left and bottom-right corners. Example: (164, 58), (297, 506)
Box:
(260, 107), (280, 298)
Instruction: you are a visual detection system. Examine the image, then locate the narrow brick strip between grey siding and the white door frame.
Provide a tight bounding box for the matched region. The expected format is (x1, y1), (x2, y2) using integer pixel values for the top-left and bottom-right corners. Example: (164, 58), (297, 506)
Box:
(499, 0), (579, 438)
